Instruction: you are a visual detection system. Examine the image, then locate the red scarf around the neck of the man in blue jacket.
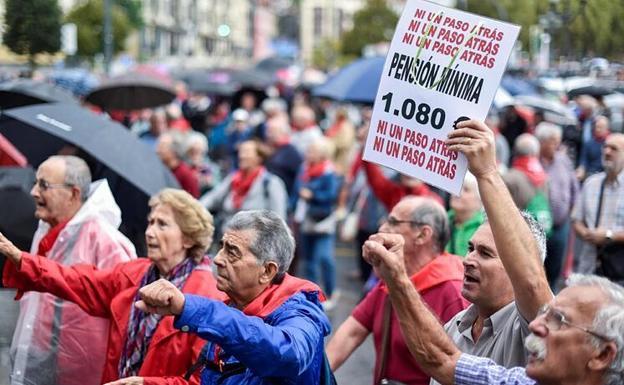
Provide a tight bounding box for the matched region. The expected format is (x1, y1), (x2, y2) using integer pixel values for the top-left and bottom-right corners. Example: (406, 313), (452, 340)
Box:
(243, 274), (325, 318)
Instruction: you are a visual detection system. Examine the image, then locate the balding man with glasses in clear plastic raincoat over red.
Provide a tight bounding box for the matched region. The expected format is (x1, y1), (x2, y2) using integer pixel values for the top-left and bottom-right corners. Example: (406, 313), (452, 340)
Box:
(5, 156), (135, 385)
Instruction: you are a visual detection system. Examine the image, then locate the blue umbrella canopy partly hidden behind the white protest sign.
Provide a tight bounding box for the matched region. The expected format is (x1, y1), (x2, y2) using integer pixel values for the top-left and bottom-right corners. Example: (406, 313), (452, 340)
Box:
(312, 57), (386, 104)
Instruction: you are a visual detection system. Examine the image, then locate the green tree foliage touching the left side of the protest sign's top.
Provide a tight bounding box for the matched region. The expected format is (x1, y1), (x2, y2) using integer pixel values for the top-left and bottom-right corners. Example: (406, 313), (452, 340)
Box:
(341, 0), (399, 57)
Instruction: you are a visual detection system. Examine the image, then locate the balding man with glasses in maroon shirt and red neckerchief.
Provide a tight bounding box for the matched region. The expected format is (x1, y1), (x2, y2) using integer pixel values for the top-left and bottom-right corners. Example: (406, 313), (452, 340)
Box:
(327, 197), (467, 384)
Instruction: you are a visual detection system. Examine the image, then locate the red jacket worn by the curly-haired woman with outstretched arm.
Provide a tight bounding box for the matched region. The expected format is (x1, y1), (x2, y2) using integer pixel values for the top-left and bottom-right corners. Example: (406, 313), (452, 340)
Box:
(3, 253), (226, 385)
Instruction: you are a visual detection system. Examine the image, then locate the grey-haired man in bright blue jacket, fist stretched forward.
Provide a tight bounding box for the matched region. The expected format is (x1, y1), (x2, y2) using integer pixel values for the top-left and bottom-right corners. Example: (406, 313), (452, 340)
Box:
(132, 210), (330, 385)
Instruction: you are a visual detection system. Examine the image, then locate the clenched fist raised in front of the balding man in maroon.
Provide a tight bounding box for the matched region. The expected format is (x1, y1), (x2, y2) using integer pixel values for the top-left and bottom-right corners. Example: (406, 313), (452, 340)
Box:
(362, 233), (407, 282)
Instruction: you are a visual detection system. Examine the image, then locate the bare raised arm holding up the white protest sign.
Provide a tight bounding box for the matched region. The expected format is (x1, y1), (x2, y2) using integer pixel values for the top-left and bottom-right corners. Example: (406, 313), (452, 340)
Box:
(447, 120), (553, 321)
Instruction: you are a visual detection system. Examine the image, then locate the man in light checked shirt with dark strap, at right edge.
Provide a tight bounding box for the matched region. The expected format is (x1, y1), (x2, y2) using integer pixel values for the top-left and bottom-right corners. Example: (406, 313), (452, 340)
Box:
(572, 134), (624, 284)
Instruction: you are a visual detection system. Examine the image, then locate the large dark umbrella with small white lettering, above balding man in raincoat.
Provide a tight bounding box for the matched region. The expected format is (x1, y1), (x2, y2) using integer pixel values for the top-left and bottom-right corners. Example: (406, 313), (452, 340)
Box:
(0, 104), (179, 252)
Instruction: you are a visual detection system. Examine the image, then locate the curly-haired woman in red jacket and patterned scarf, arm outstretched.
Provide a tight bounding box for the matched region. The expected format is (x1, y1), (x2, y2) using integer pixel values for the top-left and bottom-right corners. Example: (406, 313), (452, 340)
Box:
(0, 189), (223, 384)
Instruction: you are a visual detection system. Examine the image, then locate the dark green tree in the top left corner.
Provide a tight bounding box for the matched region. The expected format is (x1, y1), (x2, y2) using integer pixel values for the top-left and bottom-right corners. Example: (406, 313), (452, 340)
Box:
(3, 0), (61, 64)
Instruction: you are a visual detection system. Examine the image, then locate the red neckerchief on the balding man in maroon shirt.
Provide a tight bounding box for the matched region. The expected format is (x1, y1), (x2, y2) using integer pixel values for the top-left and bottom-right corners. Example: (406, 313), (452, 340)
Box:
(381, 253), (464, 293)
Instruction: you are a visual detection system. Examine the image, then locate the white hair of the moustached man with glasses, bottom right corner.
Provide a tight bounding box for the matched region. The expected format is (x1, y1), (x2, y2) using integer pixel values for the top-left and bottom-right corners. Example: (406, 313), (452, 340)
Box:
(566, 274), (624, 385)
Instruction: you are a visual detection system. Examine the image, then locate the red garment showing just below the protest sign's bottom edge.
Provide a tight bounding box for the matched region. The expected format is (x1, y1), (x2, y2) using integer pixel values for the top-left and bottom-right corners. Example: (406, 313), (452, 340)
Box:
(362, 161), (444, 212)
